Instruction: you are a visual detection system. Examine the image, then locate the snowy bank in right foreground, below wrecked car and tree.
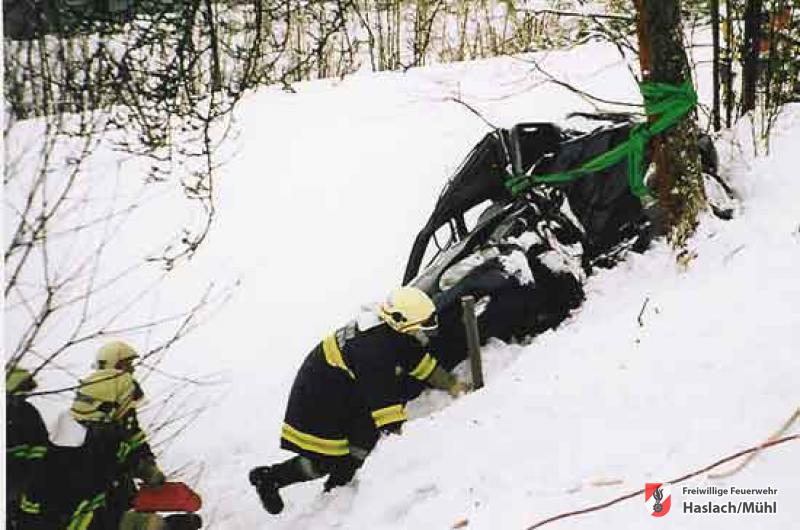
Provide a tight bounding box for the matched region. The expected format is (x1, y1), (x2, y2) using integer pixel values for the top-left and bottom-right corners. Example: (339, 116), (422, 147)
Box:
(223, 109), (800, 529)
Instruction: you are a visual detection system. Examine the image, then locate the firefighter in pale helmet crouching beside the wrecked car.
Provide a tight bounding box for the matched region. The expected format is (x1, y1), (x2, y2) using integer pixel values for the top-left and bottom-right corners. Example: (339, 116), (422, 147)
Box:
(249, 287), (465, 514)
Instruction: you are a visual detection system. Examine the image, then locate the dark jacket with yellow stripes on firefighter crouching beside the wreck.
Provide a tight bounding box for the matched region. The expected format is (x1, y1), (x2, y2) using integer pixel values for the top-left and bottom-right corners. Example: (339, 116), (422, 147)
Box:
(281, 316), (437, 459)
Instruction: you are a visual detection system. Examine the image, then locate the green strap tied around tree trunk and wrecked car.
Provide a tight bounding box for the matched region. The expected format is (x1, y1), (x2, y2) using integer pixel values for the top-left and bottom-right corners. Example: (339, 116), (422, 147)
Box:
(506, 81), (697, 198)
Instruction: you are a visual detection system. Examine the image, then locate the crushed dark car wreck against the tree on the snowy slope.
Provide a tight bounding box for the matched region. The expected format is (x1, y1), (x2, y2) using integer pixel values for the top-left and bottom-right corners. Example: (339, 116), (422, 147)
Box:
(403, 114), (733, 395)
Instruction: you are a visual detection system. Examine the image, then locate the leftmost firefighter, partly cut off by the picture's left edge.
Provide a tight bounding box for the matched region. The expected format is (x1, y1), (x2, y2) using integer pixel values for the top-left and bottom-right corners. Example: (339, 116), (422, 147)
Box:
(6, 366), (50, 529)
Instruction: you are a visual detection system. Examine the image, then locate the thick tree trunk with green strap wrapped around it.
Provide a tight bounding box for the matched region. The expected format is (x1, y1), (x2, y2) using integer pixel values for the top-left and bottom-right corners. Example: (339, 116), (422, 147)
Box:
(636, 0), (706, 250)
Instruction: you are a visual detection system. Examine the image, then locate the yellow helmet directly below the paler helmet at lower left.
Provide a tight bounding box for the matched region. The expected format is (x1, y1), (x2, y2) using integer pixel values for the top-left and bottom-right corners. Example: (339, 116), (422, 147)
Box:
(70, 368), (143, 422)
